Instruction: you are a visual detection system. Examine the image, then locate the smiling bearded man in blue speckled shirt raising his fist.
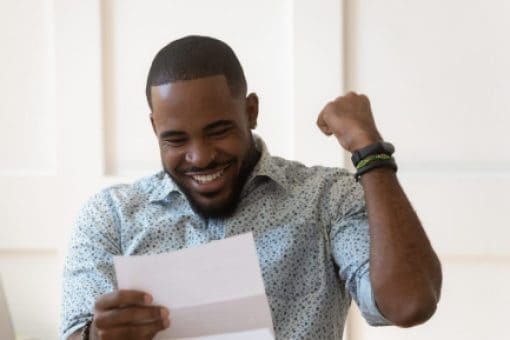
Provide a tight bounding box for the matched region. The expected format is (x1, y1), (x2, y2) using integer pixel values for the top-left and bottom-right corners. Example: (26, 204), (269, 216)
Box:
(62, 36), (441, 339)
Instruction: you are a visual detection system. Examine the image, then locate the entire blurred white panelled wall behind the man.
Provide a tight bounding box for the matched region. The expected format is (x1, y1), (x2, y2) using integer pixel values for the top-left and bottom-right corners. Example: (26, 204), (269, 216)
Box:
(0, 0), (510, 340)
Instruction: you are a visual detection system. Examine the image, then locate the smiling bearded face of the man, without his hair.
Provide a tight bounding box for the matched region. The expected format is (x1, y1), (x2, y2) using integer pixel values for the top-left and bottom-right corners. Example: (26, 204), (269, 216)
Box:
(151, 75), (258, 217)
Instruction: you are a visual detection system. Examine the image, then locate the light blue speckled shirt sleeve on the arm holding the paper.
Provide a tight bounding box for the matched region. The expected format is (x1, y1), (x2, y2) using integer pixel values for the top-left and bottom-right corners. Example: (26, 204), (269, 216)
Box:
(60, 191), (121, 339)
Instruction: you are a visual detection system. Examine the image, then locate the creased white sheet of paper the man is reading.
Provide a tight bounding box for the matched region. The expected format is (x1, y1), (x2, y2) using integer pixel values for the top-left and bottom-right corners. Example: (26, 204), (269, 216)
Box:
(114, 233), (273, 340)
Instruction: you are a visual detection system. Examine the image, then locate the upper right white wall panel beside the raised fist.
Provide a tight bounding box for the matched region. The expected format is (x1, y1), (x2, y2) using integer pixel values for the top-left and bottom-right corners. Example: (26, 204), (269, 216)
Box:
(346, 0), (510, 167)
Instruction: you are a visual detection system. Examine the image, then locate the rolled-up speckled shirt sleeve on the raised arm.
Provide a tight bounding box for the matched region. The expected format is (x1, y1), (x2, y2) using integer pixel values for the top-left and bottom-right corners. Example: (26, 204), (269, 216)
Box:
(330, 176), (391, 326)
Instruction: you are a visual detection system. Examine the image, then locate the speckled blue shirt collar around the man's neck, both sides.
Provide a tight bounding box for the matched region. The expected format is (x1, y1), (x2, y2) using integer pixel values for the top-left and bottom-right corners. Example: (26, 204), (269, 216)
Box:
(149, 134), (287, 202)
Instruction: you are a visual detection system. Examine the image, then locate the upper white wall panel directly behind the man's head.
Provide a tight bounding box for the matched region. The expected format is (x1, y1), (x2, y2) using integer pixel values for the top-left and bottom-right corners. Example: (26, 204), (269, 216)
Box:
(104, 0), (292, 174)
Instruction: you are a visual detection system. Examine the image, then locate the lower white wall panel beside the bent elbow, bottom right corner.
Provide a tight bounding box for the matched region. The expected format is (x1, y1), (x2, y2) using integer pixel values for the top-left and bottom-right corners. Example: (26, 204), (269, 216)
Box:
(351, 257), (510, 340)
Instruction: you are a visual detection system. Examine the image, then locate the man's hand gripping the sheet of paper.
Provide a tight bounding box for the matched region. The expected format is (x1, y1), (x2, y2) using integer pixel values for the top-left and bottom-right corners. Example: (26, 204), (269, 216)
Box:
(89, 290), (170, 340)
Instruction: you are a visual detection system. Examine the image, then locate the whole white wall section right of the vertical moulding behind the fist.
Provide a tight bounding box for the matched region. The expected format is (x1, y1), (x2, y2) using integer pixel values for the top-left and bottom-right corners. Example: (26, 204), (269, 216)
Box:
(345, 0), (510, 340)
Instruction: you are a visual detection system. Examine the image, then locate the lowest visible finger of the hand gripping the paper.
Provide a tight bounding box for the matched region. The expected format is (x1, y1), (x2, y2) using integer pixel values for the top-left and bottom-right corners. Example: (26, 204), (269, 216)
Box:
(97, 320), (170, 340)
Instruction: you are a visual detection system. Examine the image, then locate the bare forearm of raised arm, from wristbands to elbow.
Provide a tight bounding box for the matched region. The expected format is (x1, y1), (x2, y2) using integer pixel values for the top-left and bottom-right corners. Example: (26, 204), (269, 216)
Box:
(361, 168), (442, 326)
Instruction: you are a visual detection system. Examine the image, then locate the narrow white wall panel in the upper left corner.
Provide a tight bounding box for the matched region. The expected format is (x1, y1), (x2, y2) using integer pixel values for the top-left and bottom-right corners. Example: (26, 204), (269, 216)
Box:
(0, 0), (56, 176)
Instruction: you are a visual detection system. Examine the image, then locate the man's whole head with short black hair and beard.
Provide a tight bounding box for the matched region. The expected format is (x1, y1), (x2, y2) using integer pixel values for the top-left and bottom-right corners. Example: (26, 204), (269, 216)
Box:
(146, 36), (259, 217)
